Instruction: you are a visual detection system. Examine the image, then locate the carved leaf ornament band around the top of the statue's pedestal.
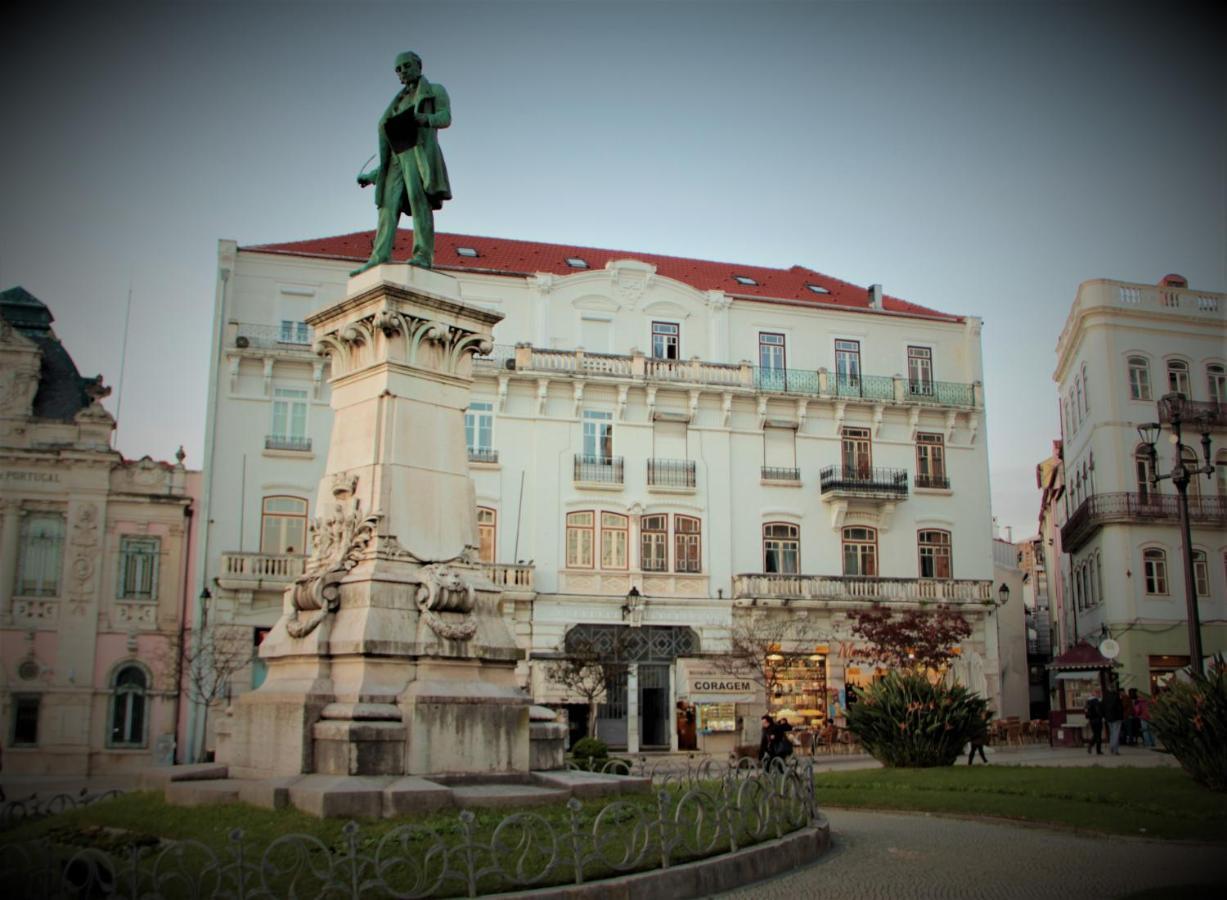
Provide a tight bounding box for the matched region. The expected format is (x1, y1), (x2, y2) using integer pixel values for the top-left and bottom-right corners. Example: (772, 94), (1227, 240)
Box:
(314, 309), (494, 374)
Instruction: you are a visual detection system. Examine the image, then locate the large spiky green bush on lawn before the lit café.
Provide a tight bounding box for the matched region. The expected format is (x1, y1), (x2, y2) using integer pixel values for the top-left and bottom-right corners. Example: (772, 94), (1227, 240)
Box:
(848, 672), (989, 769)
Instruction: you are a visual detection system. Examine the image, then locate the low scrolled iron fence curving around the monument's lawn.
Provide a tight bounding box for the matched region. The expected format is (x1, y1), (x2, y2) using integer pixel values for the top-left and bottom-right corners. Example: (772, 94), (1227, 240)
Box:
(0, 760), (820, 899)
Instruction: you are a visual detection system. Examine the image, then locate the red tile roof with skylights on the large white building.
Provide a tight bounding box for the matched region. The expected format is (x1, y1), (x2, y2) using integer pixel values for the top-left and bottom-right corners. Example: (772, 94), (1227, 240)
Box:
(243, 228), (963, 322)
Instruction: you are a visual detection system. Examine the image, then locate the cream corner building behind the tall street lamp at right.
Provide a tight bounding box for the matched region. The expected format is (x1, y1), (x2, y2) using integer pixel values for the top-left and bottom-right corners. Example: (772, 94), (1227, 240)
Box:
(1053, 275), (1227, 692)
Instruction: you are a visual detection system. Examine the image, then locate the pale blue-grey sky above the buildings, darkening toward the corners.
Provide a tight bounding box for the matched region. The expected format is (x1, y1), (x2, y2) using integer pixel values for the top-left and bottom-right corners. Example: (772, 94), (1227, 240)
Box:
(0, 0), (1227, 537)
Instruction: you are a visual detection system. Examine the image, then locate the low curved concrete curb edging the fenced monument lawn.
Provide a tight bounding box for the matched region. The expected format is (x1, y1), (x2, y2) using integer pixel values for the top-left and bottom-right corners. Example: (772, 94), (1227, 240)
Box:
(483, 813), (831, 900)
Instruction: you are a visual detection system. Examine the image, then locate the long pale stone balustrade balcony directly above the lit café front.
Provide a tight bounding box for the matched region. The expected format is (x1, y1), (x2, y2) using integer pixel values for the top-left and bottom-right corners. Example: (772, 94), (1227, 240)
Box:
(733, 573), (994, 603)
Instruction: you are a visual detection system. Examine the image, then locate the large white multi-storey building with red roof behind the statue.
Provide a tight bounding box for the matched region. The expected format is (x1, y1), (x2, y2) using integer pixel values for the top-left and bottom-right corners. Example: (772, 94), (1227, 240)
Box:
(196, 232), (999, 750)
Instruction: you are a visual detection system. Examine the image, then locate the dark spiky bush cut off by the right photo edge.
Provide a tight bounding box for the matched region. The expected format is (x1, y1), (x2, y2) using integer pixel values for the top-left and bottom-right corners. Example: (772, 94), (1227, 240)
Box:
(1151, 661), (1227, 791)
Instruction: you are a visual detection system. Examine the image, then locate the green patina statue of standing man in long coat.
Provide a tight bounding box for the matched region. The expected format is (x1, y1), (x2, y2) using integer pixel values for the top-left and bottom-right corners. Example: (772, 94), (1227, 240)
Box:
(350, 52), (452, 275)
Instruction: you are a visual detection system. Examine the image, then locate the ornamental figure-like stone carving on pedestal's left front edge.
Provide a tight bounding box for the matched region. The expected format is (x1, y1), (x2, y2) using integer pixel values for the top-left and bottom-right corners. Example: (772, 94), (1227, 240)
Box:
(286, 473), (379, 637)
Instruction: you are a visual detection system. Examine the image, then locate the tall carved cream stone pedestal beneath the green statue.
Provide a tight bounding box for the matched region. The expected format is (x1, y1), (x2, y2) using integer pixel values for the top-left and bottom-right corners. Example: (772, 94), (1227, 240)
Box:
(217, 265), (529, 777)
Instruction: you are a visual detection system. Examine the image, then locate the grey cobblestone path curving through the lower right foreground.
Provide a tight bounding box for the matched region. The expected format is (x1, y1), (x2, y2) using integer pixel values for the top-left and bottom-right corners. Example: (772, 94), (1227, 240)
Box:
(720, 809), (1227, 900)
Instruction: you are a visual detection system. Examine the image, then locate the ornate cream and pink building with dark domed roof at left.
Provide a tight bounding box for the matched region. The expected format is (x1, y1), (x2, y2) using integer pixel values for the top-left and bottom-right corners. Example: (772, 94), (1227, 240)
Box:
(0, 287), (199, 775)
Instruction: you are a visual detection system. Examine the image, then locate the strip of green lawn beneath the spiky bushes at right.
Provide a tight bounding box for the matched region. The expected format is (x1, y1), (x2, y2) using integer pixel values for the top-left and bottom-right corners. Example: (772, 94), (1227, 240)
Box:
(815, 766), (1227, 841)
